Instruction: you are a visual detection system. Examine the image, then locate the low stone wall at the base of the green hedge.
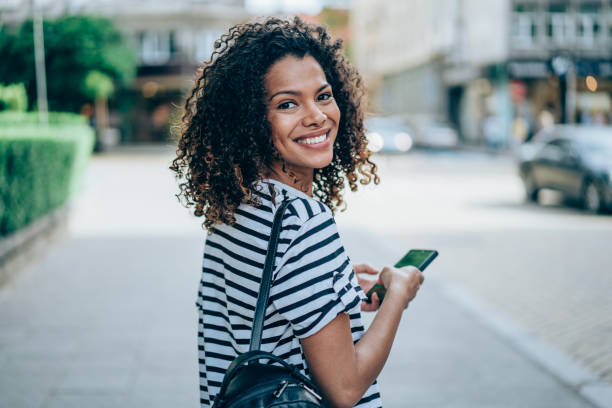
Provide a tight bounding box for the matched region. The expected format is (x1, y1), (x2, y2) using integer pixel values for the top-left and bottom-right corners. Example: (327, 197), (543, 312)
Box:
(0, 204), (70, 289)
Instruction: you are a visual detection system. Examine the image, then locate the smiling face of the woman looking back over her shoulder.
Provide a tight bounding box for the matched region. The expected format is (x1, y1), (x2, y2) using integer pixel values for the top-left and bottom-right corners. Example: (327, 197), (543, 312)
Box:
(264, 55), (340, 185)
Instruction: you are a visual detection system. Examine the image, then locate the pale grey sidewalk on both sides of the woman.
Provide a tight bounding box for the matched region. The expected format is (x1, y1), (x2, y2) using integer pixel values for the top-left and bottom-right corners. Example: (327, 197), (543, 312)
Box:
(0, 147), (604, 408)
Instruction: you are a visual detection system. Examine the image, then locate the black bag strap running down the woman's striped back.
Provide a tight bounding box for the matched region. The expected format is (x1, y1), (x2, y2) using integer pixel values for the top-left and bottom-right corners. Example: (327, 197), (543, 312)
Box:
(249, 200), (289, 351)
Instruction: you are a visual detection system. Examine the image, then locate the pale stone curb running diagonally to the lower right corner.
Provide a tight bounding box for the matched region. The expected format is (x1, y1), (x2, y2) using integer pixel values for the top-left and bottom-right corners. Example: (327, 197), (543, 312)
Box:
(436, 279), (612, 408)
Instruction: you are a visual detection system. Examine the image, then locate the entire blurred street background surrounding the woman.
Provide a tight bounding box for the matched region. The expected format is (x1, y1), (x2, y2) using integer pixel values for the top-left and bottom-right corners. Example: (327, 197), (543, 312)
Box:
(0, 0), (612, 408)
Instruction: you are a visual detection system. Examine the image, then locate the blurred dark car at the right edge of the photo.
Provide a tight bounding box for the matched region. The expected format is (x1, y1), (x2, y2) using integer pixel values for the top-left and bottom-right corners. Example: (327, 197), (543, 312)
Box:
(519, 126), (612, 212)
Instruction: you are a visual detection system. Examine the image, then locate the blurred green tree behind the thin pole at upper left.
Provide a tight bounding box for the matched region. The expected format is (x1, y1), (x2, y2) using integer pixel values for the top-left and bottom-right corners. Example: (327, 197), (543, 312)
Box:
(0, 16), (136, 112)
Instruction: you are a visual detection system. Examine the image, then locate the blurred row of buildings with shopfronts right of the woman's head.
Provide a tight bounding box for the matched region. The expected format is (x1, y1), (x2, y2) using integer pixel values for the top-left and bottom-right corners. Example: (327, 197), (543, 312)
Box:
(351, 0), (612, 145)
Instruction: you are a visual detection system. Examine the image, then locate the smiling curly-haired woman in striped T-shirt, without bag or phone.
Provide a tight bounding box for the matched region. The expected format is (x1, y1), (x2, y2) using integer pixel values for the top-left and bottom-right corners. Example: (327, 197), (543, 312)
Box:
(171, 18), (423, 407)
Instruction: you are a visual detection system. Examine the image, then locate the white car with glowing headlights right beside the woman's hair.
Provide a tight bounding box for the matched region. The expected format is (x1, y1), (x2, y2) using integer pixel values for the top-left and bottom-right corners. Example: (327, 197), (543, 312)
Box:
(365, 116), (413, 153)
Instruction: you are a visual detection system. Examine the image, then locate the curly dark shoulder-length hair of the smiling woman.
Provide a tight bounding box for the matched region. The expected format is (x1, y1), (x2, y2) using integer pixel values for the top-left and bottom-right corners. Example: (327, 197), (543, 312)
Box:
(170, 17), (379, 233)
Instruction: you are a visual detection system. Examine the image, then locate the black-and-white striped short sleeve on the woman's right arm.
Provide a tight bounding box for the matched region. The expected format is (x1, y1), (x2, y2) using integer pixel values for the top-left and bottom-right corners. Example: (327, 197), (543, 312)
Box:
(270, 212), (366, 338)
